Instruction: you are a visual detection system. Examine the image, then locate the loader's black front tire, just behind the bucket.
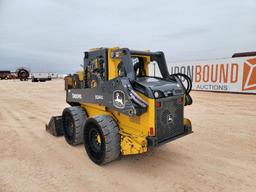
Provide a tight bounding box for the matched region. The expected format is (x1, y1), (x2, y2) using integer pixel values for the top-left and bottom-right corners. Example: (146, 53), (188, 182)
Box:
(62, 106), (87, 146)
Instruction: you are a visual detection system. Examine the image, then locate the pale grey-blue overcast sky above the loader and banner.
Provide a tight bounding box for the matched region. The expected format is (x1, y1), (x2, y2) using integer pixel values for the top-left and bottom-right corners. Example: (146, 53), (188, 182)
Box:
(0, 0), (256, 73)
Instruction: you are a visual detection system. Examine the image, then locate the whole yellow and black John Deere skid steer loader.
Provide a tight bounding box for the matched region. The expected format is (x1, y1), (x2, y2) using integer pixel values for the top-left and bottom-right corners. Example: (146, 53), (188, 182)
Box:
(46, 47), (192, 165)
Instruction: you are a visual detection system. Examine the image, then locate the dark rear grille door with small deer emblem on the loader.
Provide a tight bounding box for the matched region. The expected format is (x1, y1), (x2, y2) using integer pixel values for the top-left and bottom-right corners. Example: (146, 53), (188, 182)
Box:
(156, 96), (184, 143)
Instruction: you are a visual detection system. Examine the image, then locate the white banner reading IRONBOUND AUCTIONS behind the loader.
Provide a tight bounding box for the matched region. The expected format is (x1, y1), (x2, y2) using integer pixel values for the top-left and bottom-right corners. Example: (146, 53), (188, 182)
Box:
(170, 57), (256, 93)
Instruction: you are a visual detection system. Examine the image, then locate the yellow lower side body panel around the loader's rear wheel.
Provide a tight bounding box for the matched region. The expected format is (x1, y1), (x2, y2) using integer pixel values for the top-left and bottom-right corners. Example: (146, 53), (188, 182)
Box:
(81, 96), (155, 155)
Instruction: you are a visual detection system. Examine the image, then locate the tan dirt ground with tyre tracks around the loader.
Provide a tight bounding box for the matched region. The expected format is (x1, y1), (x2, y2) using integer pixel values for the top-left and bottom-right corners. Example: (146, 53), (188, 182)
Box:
(0, 80), (256, 192)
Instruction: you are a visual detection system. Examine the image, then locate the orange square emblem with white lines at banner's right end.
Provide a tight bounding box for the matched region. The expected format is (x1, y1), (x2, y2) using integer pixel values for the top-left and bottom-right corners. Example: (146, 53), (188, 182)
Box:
(242, 58), (256, 91)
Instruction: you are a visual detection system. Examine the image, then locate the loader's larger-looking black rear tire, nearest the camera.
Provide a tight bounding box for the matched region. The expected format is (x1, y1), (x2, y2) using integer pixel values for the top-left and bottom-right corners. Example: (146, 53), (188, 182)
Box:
(83, 115), (120, 165)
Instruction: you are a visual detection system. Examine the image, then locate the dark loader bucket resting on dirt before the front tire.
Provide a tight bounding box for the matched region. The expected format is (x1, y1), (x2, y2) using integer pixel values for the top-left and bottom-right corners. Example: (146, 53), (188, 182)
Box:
(45, 116), (63, 137)
